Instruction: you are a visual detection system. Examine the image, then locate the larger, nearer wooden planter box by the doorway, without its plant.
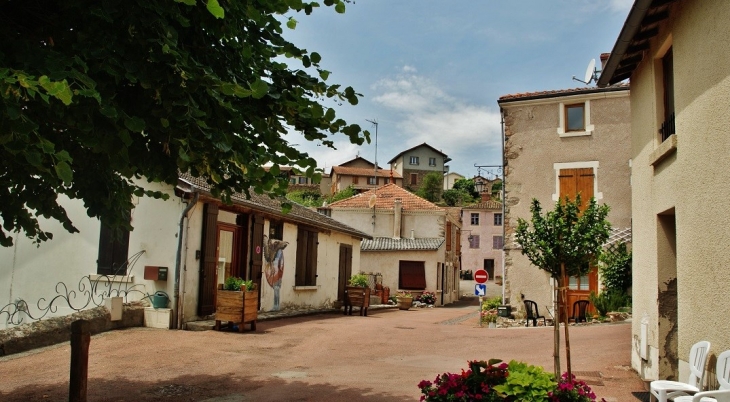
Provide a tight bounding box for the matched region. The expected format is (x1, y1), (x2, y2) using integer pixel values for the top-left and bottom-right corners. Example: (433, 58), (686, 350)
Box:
(215, 284), (259, 332)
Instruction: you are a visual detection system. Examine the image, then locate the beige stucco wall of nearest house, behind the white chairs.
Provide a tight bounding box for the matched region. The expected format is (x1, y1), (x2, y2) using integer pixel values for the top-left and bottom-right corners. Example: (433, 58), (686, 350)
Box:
(631, 0), (730, 378)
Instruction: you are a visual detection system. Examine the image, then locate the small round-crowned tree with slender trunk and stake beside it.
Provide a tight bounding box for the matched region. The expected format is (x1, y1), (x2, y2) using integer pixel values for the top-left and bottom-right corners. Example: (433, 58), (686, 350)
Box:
(515, 195), (611, 378)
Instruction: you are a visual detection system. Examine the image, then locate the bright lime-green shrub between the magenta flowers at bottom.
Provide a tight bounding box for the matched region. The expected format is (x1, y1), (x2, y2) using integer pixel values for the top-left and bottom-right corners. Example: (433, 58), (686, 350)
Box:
(494, 360), (558, 402)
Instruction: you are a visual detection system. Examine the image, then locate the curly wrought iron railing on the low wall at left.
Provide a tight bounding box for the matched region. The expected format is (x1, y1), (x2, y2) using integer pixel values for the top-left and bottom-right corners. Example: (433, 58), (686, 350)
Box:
(0, 250), (146, 326)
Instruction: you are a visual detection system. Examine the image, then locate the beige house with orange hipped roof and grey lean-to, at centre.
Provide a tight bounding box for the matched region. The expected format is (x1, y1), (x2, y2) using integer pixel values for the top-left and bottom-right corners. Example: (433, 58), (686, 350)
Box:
(326, 183), (461, 304)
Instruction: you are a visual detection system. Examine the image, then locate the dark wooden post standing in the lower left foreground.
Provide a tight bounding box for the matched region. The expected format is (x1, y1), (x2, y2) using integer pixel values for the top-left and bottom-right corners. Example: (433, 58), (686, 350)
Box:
(68, 320), (91, 402)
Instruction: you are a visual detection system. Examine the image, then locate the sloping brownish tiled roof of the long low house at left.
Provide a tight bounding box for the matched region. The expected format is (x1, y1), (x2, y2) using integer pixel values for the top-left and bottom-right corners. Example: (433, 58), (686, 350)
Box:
(180, 174), (372, 239)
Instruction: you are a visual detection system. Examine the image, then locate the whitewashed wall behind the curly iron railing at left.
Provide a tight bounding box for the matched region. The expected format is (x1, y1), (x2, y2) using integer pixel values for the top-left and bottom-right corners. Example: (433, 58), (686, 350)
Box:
(0, 183), (184, 329)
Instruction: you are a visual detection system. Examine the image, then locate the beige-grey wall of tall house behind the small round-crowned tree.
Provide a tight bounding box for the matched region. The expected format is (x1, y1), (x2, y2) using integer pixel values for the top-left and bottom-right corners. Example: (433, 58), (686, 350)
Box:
(498, 91), (631, 313)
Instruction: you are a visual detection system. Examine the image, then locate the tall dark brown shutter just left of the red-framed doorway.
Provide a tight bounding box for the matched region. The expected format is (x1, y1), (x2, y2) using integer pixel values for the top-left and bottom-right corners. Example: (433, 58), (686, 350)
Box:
(198, 204), (218, 316)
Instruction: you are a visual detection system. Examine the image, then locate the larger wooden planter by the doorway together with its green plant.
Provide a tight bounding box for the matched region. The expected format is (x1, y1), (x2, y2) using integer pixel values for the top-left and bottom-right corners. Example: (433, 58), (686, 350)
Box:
(215, 276), (259, 332)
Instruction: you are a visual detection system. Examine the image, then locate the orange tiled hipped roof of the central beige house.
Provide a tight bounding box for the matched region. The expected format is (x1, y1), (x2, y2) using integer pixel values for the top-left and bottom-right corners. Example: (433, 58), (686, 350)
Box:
(330, 183), (444, 211)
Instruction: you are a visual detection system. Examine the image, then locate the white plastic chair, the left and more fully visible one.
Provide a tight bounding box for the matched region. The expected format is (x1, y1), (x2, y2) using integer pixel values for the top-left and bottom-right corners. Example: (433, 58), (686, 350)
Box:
(649, 341), (710, 402)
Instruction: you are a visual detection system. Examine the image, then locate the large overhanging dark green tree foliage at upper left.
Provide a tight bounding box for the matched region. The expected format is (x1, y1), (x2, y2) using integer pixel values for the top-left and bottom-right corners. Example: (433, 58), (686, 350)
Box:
(0, 0), (368, 246)
